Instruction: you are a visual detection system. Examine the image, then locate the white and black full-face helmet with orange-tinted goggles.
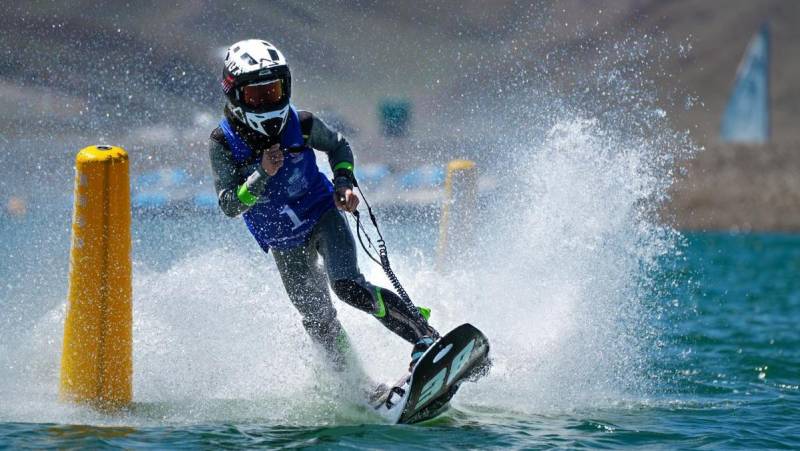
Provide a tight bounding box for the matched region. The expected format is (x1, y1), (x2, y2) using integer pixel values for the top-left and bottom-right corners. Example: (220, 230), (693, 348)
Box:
(222, 39), (292, 137)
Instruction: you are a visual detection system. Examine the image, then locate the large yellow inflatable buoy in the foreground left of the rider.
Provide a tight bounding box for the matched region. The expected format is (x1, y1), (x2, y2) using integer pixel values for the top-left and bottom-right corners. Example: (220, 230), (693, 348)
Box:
(61, 146), (133, 408)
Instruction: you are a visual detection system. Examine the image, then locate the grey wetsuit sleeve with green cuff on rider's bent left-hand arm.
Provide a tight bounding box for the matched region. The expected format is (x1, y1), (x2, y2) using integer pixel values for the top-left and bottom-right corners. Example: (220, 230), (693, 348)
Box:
(209, 129), (269, 217)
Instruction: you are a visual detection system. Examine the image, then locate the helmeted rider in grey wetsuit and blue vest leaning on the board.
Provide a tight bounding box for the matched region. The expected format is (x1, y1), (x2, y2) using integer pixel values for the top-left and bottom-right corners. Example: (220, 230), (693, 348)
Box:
(209, 39), (439, 369)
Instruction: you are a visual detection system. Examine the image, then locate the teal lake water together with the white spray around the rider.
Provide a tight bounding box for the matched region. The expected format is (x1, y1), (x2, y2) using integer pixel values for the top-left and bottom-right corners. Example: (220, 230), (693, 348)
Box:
(0, 120), (800, 449)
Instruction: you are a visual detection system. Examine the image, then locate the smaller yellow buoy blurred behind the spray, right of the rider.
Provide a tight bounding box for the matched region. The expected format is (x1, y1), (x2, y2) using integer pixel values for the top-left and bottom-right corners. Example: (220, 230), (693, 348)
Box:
(437, 160), (478, 270)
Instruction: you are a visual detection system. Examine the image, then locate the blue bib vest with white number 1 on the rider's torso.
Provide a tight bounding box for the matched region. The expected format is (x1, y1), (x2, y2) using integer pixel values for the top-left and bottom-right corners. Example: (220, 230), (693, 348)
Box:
(219, 107), (335, 252)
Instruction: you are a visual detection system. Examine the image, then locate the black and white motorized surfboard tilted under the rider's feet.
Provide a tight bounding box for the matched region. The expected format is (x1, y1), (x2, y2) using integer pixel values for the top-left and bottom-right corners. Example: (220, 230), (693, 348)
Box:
(370, 324), (491, 424)
